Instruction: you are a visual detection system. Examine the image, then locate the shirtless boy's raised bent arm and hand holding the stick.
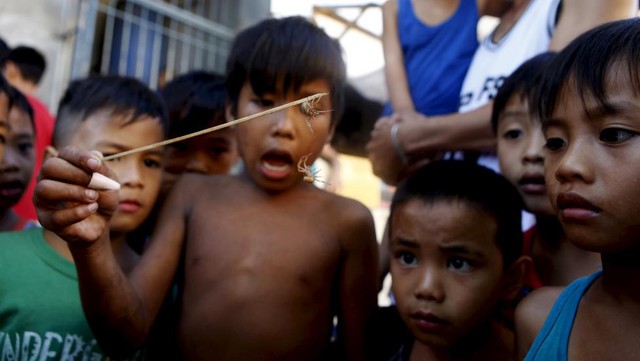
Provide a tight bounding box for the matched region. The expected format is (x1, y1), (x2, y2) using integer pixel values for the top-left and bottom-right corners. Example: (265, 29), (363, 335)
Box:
(34, 148), (184, 358)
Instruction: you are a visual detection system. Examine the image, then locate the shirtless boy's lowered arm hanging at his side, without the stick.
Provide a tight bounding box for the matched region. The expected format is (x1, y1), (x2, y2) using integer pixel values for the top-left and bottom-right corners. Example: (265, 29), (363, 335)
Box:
(338, 204), (378, 360)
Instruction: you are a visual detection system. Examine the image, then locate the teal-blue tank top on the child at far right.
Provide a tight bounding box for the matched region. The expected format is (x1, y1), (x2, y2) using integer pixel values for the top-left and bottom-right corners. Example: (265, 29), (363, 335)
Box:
(524, 271), (602, 361)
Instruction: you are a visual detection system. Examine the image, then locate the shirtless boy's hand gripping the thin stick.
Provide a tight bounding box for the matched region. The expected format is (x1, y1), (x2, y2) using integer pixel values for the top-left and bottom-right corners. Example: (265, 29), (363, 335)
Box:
(33, 147), (118, 246)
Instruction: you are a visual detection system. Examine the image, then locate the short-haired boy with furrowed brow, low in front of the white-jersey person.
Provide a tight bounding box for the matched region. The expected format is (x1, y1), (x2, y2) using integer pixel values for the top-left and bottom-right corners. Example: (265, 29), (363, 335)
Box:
(368, 161), (530, 360)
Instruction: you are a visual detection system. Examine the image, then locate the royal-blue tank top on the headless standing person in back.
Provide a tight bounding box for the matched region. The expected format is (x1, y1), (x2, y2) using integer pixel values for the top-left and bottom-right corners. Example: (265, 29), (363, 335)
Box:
(385, 0), (478, 115)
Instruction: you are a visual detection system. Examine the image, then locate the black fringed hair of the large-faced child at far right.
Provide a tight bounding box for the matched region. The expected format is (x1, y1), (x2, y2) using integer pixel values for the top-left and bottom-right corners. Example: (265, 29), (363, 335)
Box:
(536, 18), (640, 123)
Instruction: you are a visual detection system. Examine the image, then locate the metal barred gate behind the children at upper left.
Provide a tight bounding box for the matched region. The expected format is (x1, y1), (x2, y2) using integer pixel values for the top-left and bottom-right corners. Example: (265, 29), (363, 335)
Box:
(71, 0), (234, 89)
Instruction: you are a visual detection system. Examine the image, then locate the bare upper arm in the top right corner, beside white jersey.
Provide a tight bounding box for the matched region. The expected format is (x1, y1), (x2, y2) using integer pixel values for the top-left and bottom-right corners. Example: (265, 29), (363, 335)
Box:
(549, 0), (638, 51)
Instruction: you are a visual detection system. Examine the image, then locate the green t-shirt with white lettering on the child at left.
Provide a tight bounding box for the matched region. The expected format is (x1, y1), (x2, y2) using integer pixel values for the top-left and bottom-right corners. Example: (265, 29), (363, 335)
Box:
(0, 228), (132, 361)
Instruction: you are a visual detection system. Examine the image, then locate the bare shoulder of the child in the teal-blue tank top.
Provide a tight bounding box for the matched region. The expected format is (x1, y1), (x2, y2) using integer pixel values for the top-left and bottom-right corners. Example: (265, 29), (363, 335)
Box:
(515, 287), (564, 359)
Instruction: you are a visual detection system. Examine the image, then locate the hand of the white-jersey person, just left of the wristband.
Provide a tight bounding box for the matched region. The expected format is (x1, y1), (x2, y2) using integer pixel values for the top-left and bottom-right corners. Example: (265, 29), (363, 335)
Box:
(366, 114), (405, 185)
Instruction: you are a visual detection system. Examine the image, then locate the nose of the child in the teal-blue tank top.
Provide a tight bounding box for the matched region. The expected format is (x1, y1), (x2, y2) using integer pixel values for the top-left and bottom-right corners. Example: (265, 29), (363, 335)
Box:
(554, 140), (596, 183)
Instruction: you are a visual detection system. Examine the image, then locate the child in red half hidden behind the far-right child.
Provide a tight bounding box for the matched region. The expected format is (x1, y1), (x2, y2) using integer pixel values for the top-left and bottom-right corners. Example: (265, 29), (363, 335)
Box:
(491, 53), (600, 293)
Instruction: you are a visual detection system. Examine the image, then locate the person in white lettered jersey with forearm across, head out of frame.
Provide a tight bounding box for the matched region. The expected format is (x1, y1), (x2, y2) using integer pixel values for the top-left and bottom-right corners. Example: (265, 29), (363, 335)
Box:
(367, 0), (638, 184)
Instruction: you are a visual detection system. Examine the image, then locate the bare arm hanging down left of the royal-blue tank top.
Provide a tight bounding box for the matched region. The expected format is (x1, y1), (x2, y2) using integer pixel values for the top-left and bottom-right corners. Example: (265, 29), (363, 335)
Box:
(382, 0), (415, 112)
